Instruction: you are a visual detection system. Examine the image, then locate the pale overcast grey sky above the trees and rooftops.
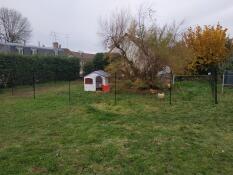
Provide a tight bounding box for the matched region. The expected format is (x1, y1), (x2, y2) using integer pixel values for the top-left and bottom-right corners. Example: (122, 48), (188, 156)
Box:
(0, 0), (233, 53)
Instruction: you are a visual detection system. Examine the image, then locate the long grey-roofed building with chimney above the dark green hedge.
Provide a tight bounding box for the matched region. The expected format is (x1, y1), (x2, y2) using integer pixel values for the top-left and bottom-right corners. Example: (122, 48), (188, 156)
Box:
(0, 42), (64, 56)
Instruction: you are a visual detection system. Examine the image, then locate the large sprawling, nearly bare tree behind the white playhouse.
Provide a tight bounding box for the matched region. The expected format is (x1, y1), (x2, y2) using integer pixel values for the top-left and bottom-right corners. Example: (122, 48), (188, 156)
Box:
(99, 7), (185, 85)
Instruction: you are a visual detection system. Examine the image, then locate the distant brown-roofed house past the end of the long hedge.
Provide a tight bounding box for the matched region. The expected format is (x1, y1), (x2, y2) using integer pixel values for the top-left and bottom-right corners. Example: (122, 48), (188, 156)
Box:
(64, 49), (95, 76)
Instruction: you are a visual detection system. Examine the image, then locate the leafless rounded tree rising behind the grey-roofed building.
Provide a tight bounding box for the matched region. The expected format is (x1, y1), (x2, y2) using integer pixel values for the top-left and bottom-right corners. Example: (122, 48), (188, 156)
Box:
(0, 8), (32, 43)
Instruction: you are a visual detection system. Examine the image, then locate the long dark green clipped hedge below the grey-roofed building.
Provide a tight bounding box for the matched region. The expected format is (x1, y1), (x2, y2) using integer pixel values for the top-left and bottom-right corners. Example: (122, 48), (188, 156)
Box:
(0, 54), (80, 87)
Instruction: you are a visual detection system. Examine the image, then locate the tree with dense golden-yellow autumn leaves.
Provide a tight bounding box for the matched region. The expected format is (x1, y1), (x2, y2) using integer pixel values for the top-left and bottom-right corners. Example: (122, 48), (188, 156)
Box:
(184, 24), (228, 71)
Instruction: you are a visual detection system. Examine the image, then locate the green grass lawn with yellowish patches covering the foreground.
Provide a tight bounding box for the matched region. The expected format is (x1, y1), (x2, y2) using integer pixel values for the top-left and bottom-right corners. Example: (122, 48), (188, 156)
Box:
(0, 82), (233, 175)
